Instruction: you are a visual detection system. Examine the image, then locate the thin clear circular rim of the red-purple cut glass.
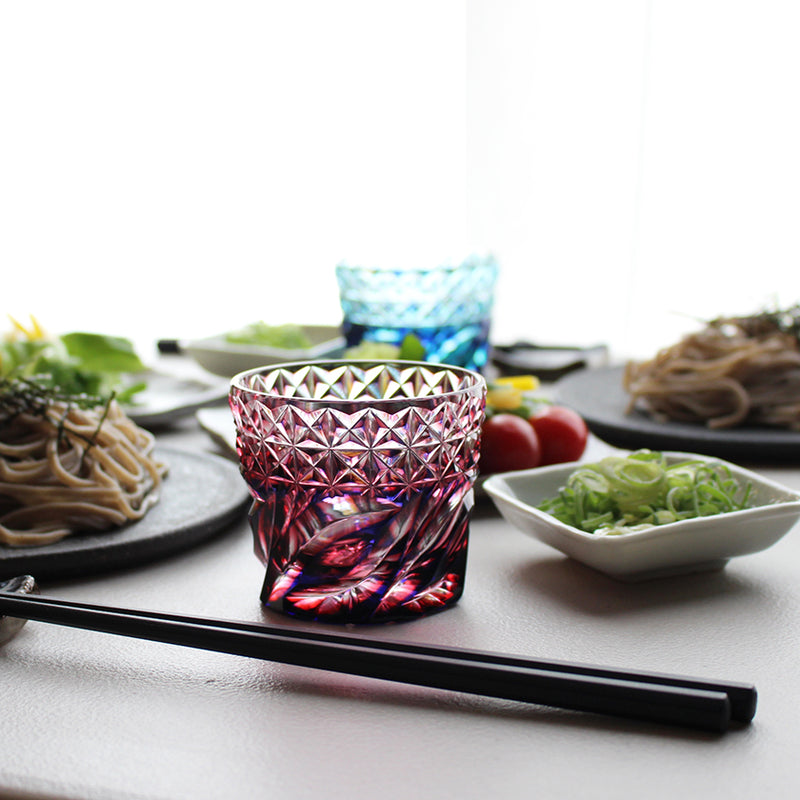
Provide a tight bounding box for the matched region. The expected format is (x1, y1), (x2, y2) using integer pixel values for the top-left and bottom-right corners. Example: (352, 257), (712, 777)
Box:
(230, 358), (486, 407)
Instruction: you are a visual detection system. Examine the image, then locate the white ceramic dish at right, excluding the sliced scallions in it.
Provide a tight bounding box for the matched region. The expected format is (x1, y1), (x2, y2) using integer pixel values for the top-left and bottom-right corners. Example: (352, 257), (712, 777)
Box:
(483, 451), (800, 581)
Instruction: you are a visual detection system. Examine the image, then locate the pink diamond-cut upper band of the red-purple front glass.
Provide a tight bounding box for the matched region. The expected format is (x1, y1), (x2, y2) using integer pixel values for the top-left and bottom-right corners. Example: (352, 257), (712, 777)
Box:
(231, 364), (484, 495)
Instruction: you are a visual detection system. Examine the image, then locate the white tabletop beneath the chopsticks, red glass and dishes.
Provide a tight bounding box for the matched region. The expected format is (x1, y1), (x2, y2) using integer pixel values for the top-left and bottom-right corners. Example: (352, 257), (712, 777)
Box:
(0, 370), (800, 800)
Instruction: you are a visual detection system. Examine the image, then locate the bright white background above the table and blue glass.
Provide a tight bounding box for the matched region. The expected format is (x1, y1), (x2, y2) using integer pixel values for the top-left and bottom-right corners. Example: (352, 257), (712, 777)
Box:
(0, 0), (800, 357)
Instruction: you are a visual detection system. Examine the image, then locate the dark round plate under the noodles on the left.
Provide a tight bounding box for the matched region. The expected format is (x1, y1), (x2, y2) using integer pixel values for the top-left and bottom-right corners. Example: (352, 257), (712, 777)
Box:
(0, 448), (250, 579)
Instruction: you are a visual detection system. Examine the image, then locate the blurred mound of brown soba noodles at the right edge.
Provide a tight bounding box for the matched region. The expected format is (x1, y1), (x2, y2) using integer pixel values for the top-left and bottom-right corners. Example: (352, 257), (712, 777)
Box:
(623, 317), (800, 430)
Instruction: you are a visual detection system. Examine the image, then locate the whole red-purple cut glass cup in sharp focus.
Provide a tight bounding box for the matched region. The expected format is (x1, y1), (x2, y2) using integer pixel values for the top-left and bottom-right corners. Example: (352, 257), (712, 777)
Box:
(229, 361), (486, 622)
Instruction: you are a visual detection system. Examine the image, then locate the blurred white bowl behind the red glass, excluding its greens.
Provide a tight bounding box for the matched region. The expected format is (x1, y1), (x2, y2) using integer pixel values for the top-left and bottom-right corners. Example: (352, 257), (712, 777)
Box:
(183, 325), (345, 378)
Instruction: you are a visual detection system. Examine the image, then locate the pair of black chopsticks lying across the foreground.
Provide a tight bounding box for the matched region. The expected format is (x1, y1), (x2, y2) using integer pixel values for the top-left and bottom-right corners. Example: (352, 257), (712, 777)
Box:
(0, 592), (756, 731)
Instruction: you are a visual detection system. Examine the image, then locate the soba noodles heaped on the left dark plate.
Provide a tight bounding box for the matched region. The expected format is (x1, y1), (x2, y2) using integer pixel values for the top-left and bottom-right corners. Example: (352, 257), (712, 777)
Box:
(0, 401), (166, 546)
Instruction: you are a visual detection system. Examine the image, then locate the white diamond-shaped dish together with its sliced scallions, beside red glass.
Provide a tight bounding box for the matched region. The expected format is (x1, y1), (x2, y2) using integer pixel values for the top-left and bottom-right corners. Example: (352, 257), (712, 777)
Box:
(484, 450), (800, 581)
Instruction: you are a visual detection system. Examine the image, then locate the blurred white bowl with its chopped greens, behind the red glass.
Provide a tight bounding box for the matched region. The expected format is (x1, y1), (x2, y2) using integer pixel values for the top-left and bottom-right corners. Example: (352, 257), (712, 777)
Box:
(182, 321), (345, 378)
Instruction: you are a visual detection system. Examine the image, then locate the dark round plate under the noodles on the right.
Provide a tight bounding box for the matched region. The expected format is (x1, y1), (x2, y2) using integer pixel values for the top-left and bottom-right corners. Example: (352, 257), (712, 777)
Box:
(555, 367), (800, 463)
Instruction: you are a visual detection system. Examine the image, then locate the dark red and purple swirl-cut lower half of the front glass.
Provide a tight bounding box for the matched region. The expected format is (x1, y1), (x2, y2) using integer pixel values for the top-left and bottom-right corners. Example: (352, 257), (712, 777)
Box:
(250, 481), (472, 623)
